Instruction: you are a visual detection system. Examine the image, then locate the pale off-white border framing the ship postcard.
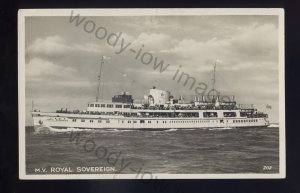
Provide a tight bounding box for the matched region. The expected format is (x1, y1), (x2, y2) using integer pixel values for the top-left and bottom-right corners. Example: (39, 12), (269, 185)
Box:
(18, 8), (286, 179)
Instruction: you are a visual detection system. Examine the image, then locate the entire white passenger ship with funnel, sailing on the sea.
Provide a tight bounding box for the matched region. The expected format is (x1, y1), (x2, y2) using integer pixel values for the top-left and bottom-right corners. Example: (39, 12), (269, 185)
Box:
(32, 58), (269, 130)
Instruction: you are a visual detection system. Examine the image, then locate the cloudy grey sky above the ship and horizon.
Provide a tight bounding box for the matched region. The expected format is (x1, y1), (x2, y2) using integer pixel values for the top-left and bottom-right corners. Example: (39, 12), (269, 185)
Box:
(25, 15), (279, 125)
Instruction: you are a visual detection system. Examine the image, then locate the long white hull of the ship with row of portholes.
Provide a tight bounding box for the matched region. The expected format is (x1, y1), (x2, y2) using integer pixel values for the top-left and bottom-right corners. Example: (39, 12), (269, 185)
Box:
(33, 113), (269, 130)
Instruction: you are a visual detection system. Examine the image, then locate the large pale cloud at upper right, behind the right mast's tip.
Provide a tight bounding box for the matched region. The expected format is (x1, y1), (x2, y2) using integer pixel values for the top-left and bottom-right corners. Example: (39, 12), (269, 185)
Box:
(160, 21), (278, 71)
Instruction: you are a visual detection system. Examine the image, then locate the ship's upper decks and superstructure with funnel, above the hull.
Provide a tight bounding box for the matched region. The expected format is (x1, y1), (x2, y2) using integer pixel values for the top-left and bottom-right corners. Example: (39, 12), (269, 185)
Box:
(51, 88), (267, 118)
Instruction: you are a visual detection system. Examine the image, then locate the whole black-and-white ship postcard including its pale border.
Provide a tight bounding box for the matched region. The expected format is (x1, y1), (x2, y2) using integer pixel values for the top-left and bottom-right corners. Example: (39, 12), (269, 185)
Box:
(18, 8), (286, 179)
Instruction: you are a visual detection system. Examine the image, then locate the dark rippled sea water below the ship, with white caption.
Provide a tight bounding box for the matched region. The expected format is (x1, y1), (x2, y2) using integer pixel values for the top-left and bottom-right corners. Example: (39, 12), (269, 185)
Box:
(26, 125), (279, 174)
